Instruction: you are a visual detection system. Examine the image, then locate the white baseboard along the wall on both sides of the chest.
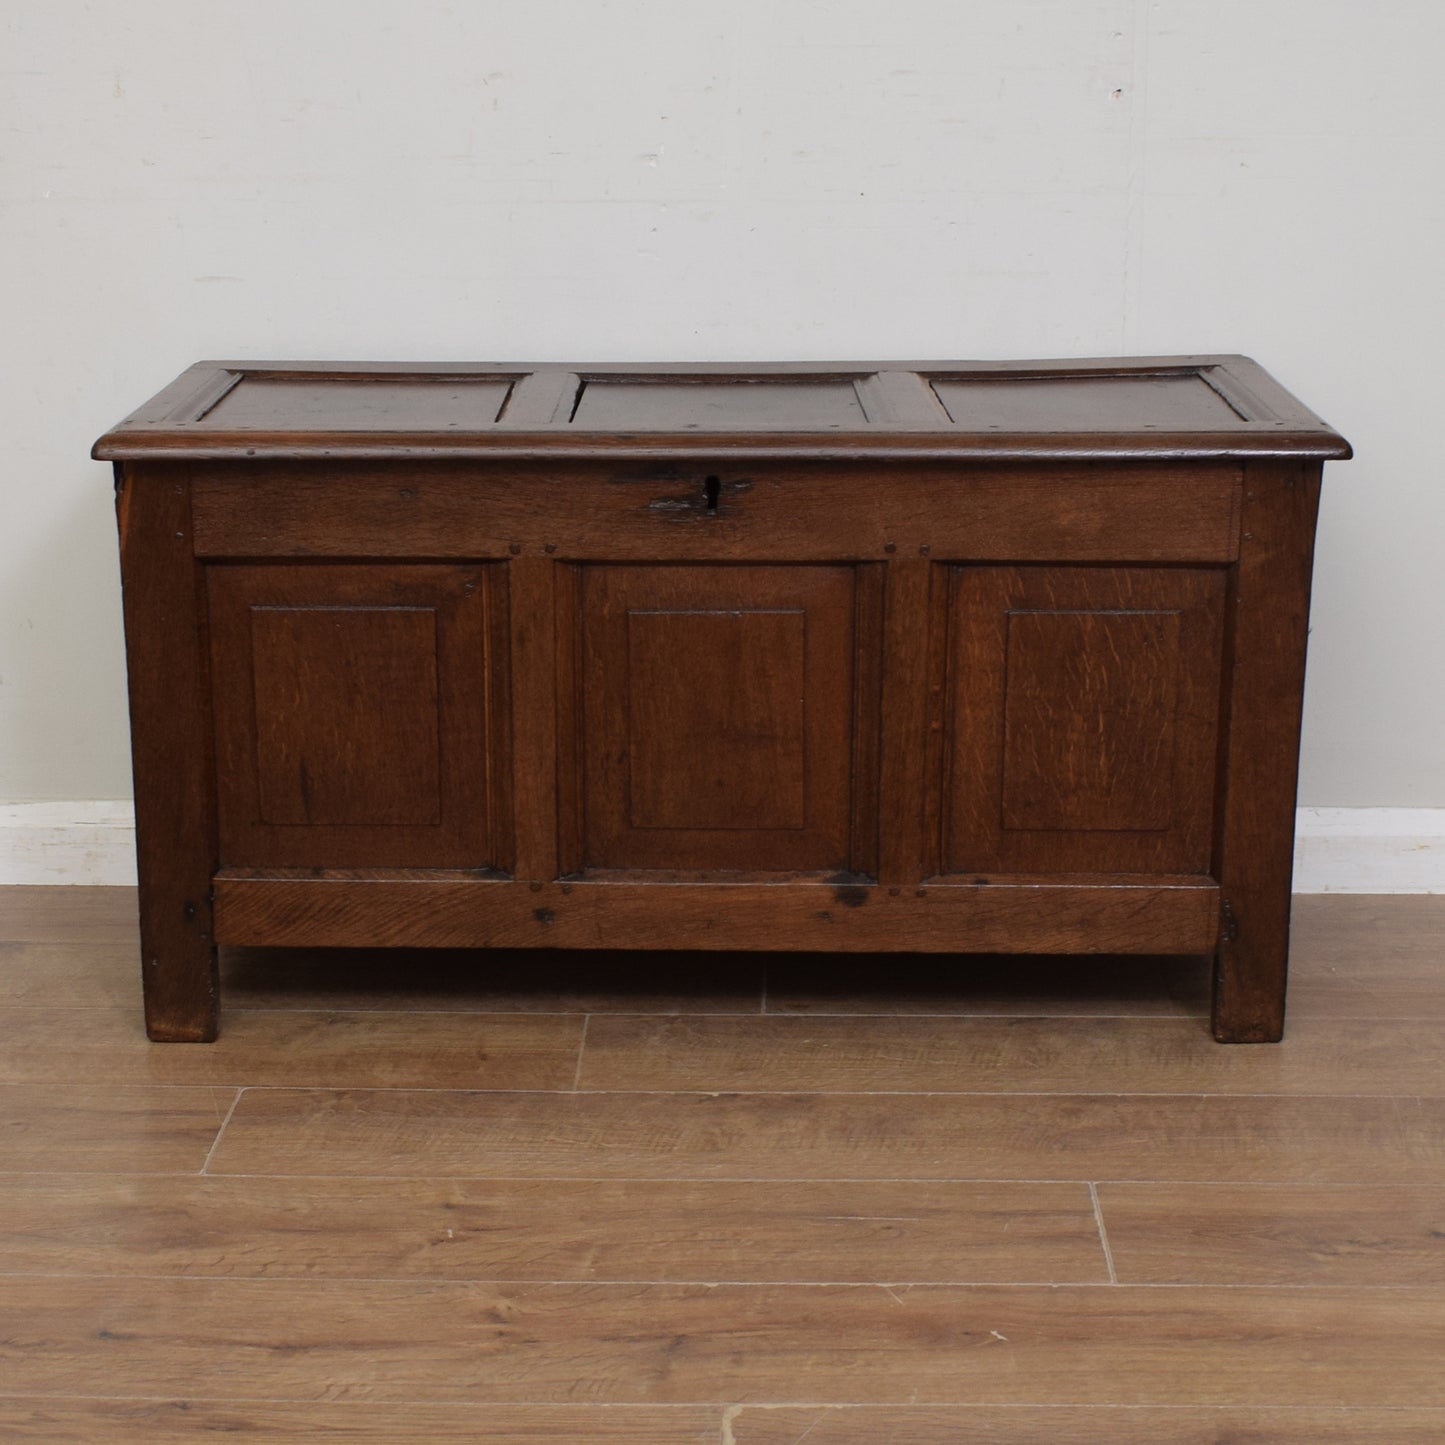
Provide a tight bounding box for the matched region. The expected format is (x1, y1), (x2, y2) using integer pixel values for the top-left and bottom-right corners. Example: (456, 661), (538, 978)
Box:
(0, 802), (1445, 893)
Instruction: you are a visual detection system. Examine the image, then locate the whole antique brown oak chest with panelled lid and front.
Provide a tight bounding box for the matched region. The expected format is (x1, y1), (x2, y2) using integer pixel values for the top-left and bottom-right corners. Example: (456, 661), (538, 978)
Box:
(94, 357), (1350, 1042)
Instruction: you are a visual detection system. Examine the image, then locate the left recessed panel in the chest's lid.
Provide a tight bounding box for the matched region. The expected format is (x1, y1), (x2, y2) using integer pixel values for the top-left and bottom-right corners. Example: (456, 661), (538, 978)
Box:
(195, 371), (514, 432)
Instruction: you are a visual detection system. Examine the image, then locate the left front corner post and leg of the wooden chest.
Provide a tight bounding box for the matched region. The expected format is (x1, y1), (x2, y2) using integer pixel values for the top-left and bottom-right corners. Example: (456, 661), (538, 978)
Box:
(116, 464), (220, 1042)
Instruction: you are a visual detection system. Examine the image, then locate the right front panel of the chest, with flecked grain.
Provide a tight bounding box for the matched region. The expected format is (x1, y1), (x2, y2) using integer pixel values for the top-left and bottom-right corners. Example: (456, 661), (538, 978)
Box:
(942, 566), (1225, 873)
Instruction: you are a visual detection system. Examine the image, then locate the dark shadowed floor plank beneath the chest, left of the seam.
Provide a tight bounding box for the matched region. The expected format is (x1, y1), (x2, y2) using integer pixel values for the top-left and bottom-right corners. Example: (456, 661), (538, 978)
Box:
(221, 948), (764, 1022)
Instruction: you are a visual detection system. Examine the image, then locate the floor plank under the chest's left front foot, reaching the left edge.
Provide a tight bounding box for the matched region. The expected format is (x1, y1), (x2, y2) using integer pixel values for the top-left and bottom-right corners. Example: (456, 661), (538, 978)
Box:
(0, 1009), (582, 1090)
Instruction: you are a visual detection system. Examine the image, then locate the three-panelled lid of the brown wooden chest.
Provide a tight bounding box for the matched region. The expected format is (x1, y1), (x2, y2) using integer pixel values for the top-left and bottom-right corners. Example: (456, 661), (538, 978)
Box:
(92, 355), (1350, 461)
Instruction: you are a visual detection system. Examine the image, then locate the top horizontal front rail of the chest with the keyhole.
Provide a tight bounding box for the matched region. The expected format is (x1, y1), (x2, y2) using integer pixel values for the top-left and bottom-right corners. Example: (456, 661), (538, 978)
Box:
(186, 455), (1240, 562)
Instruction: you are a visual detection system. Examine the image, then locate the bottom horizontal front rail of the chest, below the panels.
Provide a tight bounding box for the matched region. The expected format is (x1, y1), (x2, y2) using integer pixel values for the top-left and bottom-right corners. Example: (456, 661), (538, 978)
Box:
(215, 872), (1220, 954)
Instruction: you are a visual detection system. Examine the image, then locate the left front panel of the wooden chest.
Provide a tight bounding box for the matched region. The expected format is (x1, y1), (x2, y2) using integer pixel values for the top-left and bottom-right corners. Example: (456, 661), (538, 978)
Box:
(208, 564), (507, 868)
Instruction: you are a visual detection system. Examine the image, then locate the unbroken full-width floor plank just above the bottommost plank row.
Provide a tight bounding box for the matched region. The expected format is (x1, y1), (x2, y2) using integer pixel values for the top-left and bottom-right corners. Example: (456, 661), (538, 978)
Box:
(0, 1279), (1445, 1407)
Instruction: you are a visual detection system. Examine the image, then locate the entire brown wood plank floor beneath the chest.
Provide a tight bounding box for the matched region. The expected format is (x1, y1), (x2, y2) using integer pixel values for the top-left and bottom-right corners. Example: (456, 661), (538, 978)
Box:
(0, 889), (1445, 1445)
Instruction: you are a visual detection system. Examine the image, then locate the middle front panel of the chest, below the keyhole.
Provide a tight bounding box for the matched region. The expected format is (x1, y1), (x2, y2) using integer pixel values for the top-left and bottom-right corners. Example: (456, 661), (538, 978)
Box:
(574, 566), (879, 873)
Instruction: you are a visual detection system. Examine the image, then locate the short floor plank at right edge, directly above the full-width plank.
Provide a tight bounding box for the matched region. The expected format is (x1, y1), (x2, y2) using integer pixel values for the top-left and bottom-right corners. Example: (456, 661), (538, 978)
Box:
(1098, 1183), (1445, 1288)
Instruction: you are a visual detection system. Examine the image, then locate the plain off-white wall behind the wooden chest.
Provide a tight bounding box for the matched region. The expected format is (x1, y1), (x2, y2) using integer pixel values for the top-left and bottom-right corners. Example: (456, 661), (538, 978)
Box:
(0, 0), (1445, 808)
